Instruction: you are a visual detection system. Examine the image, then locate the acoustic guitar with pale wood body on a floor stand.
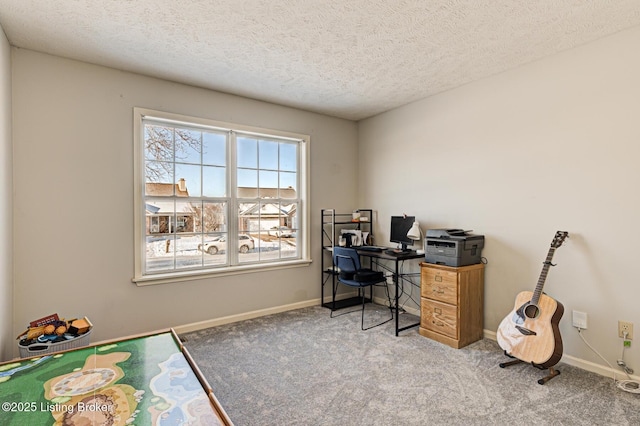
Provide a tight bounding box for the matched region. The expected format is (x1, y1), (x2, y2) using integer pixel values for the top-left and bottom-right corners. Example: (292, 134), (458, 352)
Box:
(497, 231), (569, 368)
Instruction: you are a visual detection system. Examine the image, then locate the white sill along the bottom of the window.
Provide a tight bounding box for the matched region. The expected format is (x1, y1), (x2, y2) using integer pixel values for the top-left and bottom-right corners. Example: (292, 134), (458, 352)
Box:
(131, 259), (312, 287)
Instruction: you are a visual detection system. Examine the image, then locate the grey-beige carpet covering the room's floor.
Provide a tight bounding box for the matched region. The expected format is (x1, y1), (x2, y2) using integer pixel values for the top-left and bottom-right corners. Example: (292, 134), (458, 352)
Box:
(182, 305), (640, 426)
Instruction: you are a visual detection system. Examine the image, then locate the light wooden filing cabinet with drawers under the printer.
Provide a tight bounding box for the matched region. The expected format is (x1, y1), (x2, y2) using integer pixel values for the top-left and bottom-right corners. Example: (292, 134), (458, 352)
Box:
(420, 262), (484, 349)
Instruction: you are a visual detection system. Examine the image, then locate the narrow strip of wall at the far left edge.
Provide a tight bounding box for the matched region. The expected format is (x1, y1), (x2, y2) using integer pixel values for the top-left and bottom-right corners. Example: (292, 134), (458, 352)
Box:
(0, 27), (14, 361)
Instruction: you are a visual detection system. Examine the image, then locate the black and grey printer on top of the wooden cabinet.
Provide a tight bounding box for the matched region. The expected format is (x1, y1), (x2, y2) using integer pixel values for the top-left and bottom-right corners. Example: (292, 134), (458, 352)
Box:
(424, 229), (484, 266)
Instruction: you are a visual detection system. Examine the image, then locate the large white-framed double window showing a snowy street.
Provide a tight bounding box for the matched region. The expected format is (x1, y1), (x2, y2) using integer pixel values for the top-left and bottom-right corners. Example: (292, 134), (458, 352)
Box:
(134, 108), (309, 284)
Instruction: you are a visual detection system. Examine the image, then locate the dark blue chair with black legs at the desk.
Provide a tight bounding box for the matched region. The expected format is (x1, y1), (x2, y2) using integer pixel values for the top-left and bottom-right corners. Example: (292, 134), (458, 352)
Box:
(330, 247), (393, 330)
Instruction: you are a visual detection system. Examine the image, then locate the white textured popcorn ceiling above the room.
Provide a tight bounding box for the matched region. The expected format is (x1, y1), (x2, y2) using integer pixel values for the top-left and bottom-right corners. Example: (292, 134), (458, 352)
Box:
(0, 0), (640, 120)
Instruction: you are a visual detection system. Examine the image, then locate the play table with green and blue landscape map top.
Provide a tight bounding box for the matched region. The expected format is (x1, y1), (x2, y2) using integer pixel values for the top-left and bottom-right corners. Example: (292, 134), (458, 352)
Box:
(0, 330), (231, 426)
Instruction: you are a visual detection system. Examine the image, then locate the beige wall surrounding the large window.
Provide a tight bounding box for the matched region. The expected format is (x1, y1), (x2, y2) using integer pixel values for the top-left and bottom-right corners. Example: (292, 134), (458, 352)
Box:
(13, 49), (357, 356)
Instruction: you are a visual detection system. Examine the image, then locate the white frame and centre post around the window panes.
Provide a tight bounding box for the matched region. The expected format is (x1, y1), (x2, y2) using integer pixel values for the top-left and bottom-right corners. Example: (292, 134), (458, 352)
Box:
(132, 107), (311, 286)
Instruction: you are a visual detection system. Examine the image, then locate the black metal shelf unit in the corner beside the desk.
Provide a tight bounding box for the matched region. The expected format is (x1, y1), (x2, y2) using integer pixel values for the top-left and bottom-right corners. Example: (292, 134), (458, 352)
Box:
(320, 209), (373, 311)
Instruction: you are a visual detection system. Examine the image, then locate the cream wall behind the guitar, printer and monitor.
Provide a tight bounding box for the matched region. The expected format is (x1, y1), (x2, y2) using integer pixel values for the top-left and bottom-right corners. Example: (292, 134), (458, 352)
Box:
(359, 27), (640, 371)
